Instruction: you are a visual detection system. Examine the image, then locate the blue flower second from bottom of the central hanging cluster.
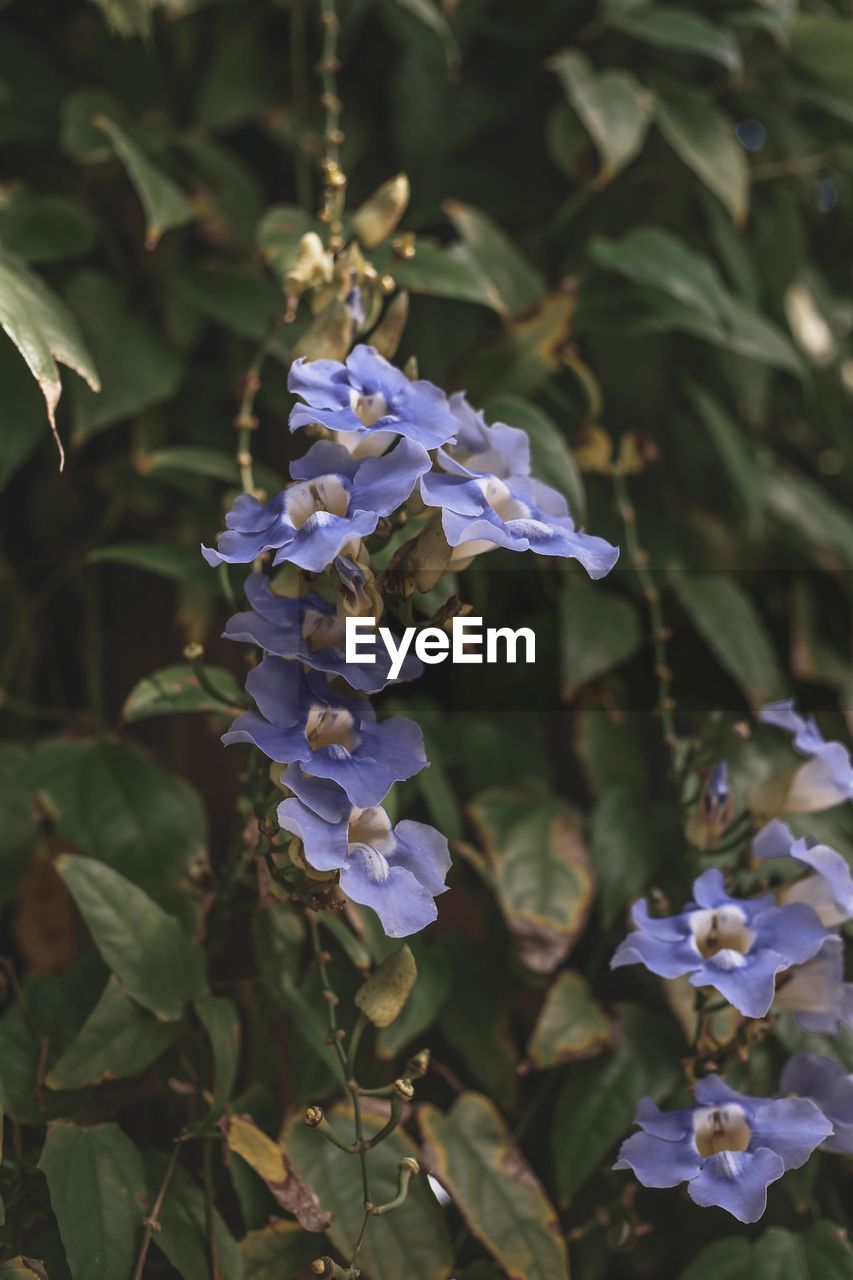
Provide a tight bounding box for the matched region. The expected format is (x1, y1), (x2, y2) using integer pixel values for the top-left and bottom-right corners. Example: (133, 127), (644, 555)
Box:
(222, 655), (428, 809)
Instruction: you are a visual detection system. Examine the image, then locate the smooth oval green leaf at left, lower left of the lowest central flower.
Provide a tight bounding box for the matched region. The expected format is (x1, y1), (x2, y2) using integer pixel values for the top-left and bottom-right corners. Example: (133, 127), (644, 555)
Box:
(56, 854), (205, 1021)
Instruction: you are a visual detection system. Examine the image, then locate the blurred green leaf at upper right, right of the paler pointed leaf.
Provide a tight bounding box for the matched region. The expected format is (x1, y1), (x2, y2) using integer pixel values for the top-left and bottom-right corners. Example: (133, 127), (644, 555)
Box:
(654, 86), (749, 224)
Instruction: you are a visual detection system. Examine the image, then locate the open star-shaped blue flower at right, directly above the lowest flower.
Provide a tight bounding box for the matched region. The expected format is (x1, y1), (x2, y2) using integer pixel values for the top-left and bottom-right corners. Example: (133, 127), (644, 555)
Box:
(611, 868), (830, 1018)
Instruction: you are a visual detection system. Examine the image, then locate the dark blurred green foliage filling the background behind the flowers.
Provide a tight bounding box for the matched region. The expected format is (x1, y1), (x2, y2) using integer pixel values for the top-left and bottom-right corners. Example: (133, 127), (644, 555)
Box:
(0, 0), (853, 1280)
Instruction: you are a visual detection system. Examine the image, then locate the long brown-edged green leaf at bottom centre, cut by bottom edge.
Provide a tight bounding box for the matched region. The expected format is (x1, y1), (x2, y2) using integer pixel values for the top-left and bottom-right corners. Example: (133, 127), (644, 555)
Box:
(418, 1093), (569, 1280)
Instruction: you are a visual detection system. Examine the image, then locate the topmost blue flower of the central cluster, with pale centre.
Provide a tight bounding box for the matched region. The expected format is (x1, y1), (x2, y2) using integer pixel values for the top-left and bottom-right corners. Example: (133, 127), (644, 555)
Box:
(287, 346), (456, 451)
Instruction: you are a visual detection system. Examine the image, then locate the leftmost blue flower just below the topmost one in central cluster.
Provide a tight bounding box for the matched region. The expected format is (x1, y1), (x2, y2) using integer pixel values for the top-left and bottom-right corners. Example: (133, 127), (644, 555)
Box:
(201, 440), (430, 573)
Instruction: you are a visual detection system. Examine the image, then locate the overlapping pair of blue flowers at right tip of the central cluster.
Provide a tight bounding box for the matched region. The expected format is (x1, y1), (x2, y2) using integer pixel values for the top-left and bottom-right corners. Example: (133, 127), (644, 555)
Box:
(420, 396), (619, 579)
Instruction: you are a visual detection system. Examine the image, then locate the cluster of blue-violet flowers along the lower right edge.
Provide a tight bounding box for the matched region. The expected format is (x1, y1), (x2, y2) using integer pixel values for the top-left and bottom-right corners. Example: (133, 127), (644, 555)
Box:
(611, 701), (853, 1222)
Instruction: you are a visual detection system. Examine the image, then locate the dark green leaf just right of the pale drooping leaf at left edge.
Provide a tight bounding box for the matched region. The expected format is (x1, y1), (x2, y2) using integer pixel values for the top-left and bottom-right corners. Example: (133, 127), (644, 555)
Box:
(69, 271), (183, 444)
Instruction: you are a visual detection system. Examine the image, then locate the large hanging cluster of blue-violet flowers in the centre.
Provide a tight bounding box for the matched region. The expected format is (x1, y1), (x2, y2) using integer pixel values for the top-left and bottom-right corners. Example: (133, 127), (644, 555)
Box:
(202, 346), (619, 937)
